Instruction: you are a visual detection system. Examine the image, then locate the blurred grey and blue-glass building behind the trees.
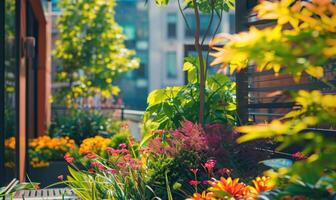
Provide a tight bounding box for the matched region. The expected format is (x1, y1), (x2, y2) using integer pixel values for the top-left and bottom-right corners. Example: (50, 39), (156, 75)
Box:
(45, 0), (234, 110)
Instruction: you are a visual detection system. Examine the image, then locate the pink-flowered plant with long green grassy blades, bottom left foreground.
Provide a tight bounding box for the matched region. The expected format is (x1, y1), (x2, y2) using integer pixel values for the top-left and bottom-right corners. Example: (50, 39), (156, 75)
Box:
(64, 144), (153, 200)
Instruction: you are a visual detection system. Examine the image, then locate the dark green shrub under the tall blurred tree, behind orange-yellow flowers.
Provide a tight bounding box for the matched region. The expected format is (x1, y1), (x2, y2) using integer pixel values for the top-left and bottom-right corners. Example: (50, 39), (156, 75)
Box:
(49, 109), (121, 144)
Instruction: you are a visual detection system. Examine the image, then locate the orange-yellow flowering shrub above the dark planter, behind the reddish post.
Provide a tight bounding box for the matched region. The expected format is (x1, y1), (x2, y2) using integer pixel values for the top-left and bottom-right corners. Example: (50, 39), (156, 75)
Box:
(5, 136), (76, 167)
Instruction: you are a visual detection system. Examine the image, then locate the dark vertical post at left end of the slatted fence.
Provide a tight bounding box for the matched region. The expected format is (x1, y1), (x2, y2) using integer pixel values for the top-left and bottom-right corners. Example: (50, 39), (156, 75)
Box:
(235, 0), (248, 124)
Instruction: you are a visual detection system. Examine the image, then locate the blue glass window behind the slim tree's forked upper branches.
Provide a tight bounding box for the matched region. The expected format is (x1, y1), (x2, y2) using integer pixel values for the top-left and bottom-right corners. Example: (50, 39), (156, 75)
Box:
(185, 13), (220, 37)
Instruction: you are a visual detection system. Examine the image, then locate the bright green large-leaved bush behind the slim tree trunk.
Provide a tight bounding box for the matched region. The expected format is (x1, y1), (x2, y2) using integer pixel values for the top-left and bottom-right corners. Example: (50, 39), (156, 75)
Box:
(144, 57), (236, 130)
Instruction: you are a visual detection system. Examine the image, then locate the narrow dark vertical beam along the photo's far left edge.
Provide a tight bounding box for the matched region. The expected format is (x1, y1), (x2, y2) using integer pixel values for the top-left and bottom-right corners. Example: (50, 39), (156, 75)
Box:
(0, 0), (5, 185)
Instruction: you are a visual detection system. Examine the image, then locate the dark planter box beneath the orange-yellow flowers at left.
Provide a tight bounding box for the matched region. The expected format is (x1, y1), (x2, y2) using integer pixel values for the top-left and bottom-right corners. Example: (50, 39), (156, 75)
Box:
(28, 161), (69, 188)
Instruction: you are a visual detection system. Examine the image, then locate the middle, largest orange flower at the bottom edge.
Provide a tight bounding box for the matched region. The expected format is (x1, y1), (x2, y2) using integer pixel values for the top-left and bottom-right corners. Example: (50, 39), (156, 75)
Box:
(209, 177), (248, 198)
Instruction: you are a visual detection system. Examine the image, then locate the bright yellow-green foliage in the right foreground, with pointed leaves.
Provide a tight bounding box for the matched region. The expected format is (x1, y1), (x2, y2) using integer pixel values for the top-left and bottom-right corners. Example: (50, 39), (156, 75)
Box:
(214, 0), (336, 199)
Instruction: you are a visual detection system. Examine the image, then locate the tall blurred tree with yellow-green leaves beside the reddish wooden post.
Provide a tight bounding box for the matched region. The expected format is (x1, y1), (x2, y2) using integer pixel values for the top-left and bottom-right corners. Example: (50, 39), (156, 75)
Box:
(54, 0), (139, 103)
